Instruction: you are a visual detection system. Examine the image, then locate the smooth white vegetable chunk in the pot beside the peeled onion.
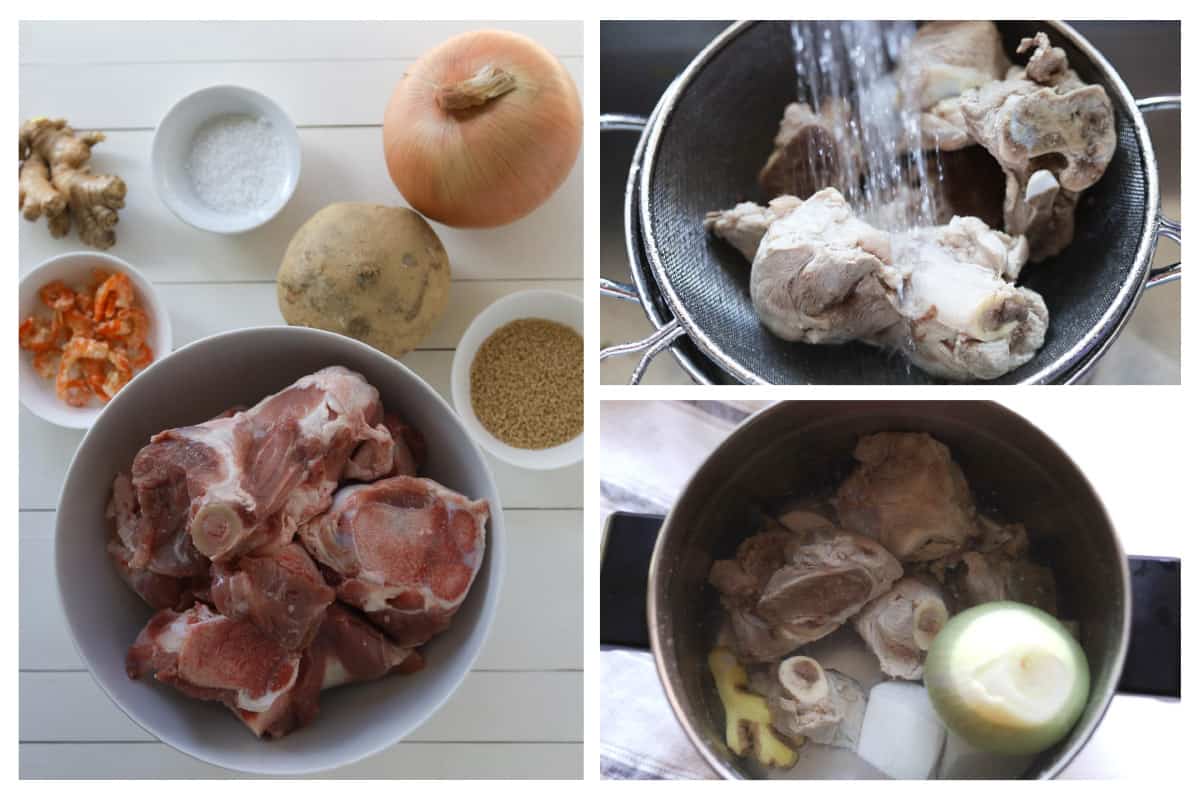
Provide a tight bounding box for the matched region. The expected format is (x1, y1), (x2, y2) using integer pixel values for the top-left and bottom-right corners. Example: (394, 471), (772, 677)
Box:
(858, 680), (946, 780)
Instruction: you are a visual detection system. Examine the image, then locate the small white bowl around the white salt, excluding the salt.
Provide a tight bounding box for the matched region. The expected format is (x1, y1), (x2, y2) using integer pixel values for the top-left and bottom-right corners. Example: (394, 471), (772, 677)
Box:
(150, 86), (300, 234)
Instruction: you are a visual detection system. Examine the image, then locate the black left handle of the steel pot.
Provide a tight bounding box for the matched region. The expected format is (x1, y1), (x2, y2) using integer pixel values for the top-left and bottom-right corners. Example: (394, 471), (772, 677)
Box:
(600, 511), (662, 650)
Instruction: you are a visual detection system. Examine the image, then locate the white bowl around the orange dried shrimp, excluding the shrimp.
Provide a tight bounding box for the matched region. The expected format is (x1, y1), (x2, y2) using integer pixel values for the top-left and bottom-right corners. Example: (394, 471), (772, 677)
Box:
(18, 251), (170, 429)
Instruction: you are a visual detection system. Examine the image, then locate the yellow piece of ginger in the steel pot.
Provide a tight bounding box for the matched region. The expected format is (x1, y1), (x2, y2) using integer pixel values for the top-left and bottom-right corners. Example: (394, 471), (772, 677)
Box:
(708, 648), (798, 769)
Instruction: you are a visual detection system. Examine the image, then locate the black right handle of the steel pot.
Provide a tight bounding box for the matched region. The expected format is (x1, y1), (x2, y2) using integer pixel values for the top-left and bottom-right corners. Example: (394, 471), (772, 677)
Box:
(1117, 555), (1181, 698)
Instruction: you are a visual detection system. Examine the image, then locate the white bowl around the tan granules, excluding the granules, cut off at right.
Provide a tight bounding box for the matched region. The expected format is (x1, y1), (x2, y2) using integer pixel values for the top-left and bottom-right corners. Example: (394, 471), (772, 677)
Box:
(450, 289), (583, 469)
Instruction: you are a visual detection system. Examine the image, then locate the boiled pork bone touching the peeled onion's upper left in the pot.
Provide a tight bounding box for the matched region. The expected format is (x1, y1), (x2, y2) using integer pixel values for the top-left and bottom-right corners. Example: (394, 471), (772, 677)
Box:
(854, 576), (949, 680)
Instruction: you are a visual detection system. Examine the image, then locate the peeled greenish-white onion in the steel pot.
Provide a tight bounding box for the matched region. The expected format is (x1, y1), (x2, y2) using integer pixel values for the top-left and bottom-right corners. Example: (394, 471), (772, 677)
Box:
(925, 601), (1091, 756)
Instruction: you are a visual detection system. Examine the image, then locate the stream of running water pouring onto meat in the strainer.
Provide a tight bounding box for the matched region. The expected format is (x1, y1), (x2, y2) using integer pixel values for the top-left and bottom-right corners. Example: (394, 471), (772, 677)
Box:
(792, 20), (941, 230)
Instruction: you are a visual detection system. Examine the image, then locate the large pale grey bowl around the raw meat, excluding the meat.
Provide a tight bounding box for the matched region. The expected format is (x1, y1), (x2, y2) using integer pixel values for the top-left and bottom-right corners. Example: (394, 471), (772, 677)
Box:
(54, 326), (506, 777)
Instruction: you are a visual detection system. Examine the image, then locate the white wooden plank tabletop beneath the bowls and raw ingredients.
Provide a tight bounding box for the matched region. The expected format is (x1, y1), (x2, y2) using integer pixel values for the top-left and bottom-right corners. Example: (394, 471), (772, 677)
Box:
(19, 23), (583, 777)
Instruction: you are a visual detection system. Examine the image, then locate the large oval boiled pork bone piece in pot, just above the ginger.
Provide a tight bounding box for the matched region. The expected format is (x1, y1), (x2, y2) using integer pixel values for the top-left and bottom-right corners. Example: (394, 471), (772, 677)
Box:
(708, 528), (904, 662)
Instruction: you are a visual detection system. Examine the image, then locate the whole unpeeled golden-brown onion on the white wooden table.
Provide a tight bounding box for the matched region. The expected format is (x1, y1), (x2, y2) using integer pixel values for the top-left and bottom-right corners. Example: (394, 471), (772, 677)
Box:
(383, 31), (583, 228)
